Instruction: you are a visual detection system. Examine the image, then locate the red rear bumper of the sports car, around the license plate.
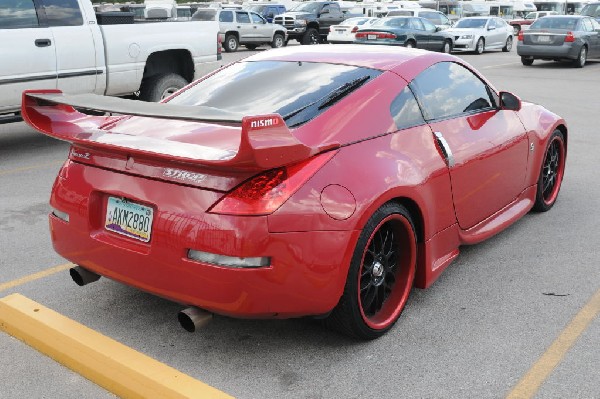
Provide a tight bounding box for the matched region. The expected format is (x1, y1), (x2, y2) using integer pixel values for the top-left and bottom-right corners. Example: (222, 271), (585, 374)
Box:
(50, 165), (360, 318)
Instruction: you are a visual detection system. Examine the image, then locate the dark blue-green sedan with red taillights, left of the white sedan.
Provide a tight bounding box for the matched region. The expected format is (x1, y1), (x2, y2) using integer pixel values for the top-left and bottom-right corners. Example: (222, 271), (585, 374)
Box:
(354, 17), (454, 53)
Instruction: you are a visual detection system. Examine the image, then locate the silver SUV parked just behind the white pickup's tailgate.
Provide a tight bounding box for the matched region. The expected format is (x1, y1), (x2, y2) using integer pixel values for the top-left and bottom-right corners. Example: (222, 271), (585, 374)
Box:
(192, 8), (287, 53)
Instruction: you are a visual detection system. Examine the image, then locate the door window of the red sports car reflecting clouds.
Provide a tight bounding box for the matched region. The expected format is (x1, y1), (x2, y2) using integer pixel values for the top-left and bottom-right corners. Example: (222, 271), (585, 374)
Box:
(411, 62), (496, 120)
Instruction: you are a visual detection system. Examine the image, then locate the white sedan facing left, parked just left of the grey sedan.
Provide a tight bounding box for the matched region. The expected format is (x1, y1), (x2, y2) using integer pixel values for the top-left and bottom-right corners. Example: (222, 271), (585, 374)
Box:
(445, 17), (513, 54)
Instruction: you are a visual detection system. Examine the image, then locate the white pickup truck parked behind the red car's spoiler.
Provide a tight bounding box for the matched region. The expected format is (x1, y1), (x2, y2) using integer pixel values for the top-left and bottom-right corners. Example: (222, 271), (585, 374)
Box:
(0, 0), (221, 123)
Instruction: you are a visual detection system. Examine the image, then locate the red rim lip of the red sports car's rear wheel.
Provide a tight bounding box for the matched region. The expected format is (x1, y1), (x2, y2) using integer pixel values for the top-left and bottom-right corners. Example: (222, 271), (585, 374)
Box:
(357, 214), (417, 330)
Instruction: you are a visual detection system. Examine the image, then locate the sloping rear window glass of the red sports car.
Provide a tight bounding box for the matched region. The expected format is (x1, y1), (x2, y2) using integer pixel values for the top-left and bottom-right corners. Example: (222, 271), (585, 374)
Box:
(169, 61), (381, 127)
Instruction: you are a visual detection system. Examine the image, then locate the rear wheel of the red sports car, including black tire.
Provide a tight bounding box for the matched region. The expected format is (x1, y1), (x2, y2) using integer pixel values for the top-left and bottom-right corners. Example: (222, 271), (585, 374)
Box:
(324, 202), (417, 340)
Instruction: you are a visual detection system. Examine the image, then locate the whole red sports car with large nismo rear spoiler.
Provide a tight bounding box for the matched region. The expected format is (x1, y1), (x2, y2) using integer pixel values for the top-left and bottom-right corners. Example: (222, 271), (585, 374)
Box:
(22, 45), (568, 339)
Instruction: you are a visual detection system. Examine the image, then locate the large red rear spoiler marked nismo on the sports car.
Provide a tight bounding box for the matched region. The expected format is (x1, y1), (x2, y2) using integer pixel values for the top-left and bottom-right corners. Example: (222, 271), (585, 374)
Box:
(21, 90), (339, 170)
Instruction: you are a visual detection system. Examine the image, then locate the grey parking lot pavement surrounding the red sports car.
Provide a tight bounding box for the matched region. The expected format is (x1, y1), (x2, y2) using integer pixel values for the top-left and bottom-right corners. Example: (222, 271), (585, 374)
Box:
(0, 50), (600, 399)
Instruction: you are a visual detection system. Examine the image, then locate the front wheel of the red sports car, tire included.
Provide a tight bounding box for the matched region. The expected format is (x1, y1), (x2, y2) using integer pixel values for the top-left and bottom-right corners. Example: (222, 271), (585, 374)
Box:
(533, 130), (567, 212)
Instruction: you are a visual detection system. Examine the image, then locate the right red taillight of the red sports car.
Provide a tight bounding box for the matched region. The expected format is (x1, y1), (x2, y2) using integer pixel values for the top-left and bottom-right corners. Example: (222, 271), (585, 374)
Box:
(209, 151), (337, 216)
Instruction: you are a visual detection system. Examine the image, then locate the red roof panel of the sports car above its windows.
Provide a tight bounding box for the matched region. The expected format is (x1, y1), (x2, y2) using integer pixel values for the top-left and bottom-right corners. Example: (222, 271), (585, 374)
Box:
(244, 44), (464, 81)
